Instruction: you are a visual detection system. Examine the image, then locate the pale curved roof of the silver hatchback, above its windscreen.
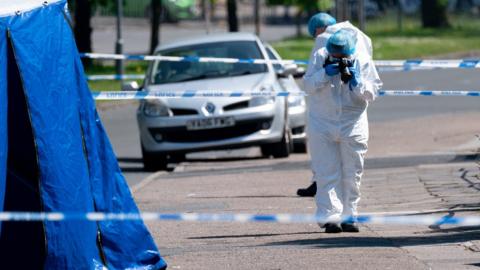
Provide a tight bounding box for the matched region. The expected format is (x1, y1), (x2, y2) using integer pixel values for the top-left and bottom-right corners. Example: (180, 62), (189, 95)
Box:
(155, 32), (258, 52)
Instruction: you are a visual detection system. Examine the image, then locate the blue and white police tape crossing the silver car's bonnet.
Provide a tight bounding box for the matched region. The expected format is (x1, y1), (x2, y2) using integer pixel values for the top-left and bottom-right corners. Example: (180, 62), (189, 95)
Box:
(92, 90), (480, 100)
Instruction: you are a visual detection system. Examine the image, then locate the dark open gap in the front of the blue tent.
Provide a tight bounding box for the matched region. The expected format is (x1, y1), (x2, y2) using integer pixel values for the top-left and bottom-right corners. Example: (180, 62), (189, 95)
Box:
(0, 33), (46, 269)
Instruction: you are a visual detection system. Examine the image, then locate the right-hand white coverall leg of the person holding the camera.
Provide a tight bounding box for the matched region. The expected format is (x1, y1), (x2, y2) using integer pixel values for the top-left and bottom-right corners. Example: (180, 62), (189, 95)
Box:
(340, 136), (367, 216)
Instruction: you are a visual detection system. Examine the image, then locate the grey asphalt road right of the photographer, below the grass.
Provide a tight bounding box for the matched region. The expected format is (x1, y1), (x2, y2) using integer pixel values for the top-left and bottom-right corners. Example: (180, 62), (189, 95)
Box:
(369, 69), (480, 121)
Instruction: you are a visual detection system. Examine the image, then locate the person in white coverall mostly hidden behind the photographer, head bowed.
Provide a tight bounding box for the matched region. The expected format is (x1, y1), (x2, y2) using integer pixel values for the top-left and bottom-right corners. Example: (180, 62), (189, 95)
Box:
(297, 13), (372, 197)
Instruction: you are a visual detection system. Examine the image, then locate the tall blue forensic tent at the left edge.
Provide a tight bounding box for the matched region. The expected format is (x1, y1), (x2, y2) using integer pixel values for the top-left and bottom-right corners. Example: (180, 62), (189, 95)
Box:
(0, 0), (166, 269)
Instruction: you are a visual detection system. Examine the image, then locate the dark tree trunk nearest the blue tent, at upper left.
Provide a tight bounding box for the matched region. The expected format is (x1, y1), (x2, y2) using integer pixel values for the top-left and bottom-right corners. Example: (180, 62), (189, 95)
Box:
(73, 0), (92, 66)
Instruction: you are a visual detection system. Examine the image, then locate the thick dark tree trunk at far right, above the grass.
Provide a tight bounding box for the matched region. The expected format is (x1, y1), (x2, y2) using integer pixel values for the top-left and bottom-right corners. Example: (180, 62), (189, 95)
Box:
(421, 0), (450, 28)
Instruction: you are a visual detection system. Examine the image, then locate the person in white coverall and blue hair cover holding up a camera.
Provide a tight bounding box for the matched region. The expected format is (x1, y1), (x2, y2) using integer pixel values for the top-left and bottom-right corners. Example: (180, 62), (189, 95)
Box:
(304, 28), (382, 233)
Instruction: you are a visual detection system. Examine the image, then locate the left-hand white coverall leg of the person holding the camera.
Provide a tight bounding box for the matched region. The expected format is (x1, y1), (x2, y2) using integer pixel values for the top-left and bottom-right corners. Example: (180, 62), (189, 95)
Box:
(309, 132), (343, 220)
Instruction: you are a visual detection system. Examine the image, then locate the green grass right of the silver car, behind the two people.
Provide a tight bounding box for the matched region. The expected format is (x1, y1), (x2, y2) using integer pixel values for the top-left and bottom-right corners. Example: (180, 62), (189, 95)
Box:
(272, 13), (480, 60)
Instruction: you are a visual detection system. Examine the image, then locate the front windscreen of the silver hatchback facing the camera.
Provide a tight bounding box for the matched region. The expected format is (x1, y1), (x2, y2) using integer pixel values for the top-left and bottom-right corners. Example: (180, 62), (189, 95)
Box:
(150, 41), (268, 84)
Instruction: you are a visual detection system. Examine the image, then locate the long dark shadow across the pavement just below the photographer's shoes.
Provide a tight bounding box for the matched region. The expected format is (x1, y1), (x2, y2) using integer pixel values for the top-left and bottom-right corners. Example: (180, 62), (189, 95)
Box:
(261, 226), (480, 248)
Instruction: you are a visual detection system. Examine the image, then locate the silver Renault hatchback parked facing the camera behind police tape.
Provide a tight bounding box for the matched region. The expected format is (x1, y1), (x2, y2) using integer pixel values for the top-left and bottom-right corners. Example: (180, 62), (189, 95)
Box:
(137, 33), (306, 170)
